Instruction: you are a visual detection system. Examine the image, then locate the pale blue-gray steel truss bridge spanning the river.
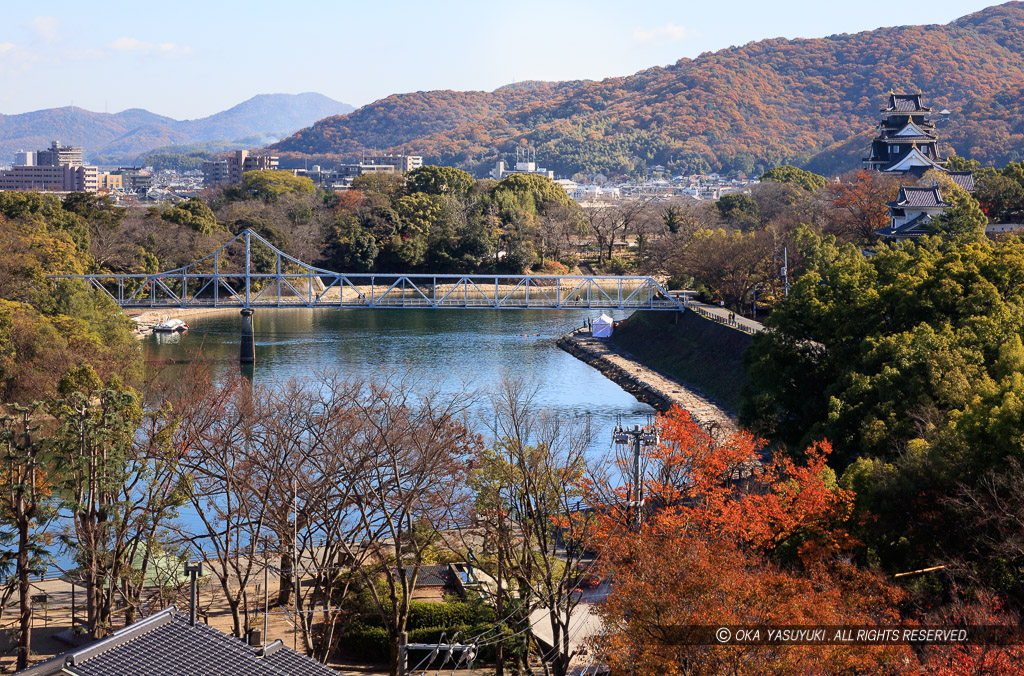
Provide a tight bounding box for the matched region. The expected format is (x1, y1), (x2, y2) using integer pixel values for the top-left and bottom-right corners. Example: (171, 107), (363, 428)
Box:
(47, 230), (683, 311)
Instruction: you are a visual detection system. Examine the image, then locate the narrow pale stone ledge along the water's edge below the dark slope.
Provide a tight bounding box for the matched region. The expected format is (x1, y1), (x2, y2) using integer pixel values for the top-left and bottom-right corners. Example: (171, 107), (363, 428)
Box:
(558, 329), (738, 433)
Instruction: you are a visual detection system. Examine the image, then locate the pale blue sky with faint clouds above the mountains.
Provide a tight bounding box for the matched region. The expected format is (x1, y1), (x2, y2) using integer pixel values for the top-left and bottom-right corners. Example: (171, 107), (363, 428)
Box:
(0, 0), (995, 119)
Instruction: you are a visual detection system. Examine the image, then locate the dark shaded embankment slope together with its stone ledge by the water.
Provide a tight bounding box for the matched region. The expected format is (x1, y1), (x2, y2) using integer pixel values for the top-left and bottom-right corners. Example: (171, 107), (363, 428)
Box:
(558, 311), (751, 431)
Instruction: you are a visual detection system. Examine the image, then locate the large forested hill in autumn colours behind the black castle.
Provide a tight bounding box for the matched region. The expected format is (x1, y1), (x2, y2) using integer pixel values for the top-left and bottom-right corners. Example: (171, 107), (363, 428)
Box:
(272, 2), (1024, 175)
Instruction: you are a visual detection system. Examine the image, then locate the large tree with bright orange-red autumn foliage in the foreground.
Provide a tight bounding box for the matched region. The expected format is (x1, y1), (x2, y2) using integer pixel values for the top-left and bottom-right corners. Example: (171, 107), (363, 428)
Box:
(587, 409), (912, 674)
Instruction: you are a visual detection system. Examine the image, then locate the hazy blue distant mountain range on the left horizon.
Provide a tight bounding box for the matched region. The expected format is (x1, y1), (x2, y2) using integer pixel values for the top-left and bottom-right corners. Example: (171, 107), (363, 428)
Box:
(0, 93), (354, 163)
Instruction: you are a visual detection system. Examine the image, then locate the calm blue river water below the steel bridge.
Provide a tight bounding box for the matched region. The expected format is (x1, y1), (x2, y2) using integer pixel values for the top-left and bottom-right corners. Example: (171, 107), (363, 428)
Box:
(144, 309), (653, 454)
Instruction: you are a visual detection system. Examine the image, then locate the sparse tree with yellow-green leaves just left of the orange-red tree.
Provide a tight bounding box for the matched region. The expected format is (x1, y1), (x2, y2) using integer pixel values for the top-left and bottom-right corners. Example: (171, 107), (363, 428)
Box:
(473, 379), (590, 676)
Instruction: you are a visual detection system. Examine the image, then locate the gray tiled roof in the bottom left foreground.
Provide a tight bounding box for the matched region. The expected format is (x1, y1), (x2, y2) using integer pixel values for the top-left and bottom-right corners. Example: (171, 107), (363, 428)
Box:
(20, 606), (337, 676)
